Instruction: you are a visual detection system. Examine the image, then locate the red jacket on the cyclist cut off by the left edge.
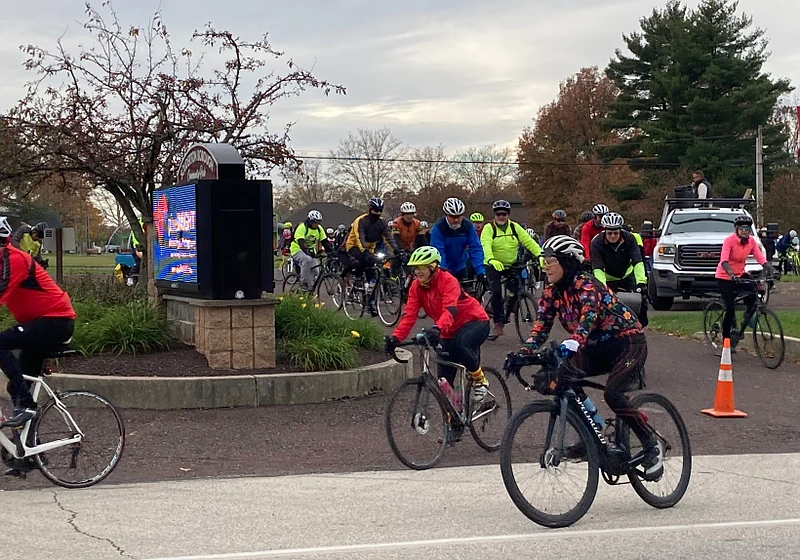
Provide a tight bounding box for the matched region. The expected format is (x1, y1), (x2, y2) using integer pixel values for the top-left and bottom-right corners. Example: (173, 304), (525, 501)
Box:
(0, 245), (75, 323)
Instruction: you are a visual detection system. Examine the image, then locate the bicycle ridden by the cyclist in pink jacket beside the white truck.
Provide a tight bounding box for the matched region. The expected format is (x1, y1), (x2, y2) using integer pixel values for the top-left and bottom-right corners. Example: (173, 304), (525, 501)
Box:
(703, 276), (786, 369)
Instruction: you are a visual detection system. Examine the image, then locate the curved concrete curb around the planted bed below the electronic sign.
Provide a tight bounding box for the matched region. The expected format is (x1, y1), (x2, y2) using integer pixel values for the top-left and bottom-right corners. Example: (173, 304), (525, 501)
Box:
(0, 349), (416, 410)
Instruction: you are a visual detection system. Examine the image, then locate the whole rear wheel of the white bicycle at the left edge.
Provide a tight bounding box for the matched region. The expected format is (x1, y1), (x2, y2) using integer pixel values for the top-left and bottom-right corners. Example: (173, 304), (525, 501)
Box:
(34, 391), (125, 488)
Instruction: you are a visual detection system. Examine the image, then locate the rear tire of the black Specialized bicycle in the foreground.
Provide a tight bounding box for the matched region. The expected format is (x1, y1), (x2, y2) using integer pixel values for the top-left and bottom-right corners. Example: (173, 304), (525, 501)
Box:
(623, 393), (692, 509)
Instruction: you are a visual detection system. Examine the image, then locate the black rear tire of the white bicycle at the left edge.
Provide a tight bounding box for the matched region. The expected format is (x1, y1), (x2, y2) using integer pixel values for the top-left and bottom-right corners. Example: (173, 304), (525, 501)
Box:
(34, 391), (125, 488)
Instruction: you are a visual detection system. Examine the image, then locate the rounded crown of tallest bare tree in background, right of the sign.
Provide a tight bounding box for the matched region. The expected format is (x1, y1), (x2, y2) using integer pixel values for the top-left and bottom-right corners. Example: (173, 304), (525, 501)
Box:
(331, 127), (405, 199)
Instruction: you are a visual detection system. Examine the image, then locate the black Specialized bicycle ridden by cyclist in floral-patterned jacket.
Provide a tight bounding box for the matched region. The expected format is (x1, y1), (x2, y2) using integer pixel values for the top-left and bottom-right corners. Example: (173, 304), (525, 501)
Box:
(500, 342), (692, 528)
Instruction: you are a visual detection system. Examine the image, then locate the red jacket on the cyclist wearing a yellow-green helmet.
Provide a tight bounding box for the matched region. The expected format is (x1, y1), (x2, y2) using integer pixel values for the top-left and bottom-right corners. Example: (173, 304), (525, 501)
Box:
(393, 269), (489, 340)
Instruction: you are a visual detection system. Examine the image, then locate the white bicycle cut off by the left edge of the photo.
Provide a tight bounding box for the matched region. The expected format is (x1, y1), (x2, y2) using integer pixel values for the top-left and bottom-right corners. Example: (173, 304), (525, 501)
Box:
(0, 346), (125, 488)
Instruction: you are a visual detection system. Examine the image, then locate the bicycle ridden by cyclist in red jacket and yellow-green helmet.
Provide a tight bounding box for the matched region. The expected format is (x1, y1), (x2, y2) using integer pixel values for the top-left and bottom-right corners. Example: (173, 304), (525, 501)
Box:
(385, 329), (511, 470)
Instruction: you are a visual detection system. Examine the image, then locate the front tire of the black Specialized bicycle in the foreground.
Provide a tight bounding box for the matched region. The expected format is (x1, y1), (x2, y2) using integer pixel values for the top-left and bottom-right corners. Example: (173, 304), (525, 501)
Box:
(500, 400), (600, 529)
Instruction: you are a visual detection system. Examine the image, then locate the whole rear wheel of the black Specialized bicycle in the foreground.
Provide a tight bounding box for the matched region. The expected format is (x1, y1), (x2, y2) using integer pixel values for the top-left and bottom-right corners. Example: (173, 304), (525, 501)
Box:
(618, 393), (692, 509)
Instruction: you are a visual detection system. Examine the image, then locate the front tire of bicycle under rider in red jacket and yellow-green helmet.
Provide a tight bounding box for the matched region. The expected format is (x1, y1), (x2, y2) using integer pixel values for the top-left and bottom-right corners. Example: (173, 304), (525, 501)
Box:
(384, 377), (448, 471)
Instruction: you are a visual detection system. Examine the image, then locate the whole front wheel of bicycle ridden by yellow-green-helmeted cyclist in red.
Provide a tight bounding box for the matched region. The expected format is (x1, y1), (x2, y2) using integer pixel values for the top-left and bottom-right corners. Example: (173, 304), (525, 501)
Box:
(385, 377), (448, 470)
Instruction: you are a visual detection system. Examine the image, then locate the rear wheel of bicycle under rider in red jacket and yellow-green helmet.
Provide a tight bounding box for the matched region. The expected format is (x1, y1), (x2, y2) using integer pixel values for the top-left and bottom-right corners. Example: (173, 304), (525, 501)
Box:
(466, 368), (511, 451)
